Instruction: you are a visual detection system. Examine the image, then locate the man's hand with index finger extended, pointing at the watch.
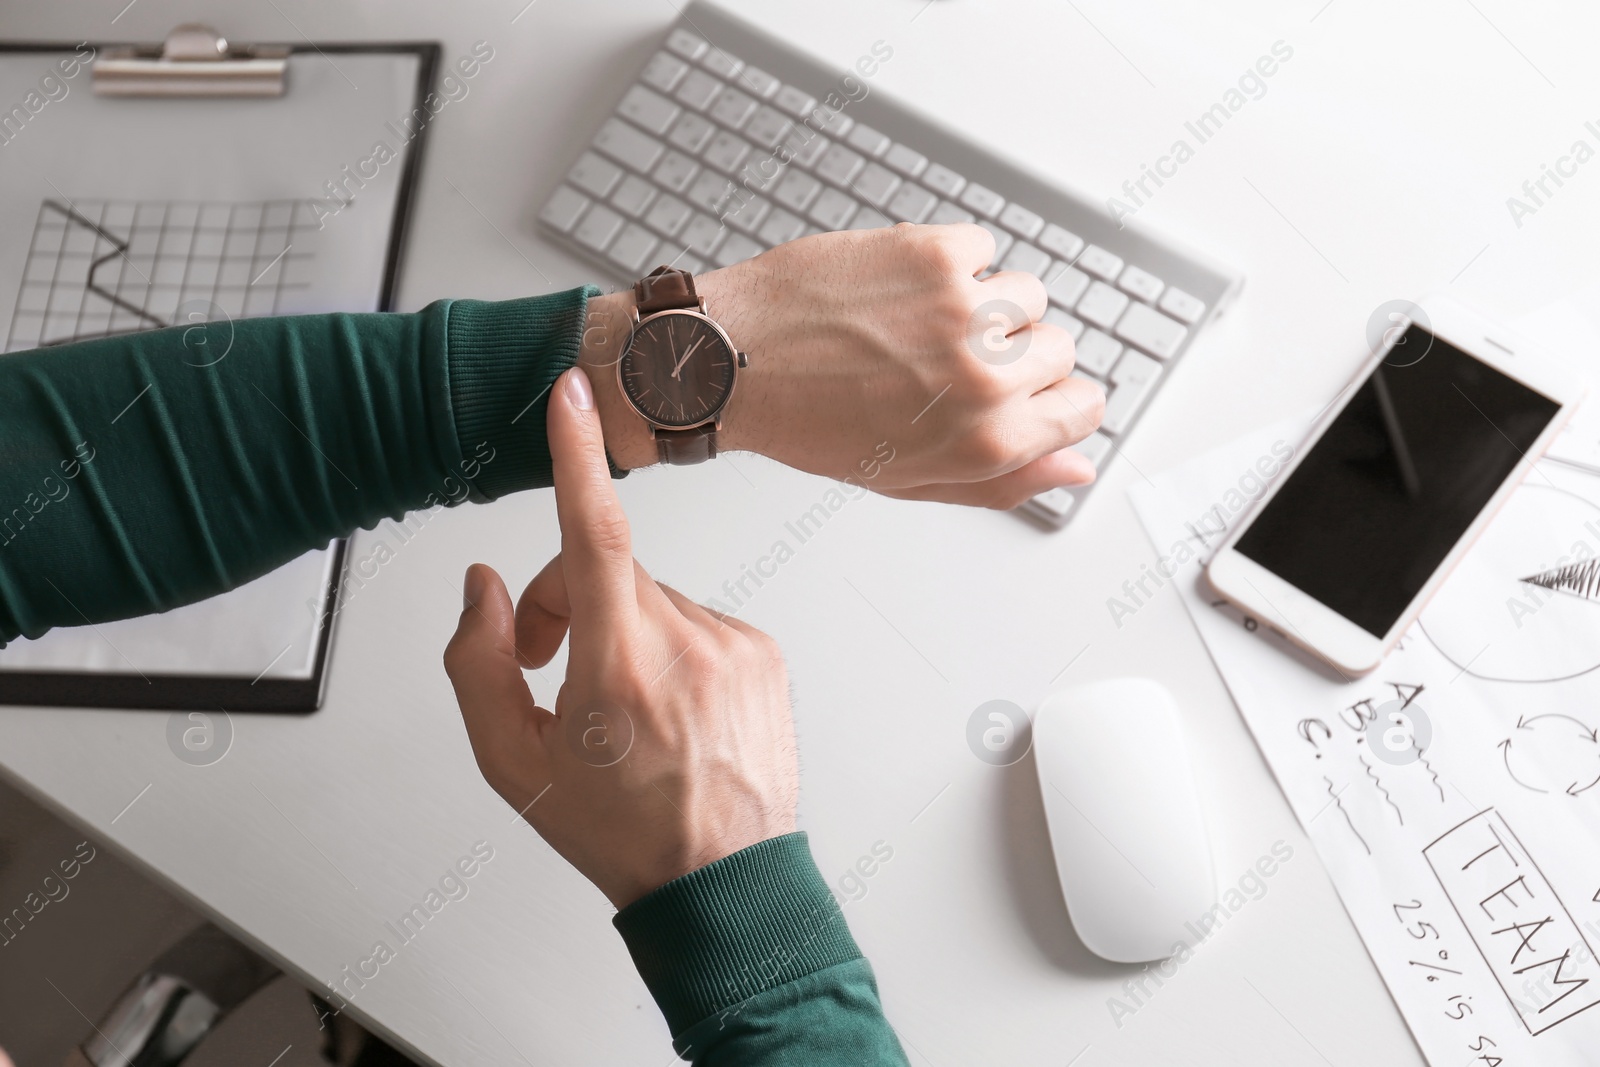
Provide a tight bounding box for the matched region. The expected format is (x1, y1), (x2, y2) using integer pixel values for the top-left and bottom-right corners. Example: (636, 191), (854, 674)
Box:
(445, 370), (798, 909)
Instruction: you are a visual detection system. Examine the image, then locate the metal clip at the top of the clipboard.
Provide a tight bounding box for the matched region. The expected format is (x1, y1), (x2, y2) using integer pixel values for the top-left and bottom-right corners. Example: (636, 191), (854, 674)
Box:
(94, 22), (290, 96)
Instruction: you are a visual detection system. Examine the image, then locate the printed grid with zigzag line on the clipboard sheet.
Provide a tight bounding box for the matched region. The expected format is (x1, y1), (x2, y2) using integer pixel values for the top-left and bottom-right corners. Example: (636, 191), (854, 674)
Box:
(5, 200), (318, 352)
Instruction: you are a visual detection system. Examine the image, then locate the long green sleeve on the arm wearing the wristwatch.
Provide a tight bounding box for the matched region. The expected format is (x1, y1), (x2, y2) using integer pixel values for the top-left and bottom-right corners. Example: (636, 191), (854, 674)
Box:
(0, 288), (598, 643)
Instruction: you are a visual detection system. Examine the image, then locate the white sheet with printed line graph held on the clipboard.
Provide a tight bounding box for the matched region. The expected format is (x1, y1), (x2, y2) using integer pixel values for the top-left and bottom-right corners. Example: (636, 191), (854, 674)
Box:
(0, 51), (419, 680)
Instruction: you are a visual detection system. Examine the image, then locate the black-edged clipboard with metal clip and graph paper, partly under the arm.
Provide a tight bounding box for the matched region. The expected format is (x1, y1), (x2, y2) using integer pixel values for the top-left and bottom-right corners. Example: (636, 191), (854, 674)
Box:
(0, 24), (440, 712)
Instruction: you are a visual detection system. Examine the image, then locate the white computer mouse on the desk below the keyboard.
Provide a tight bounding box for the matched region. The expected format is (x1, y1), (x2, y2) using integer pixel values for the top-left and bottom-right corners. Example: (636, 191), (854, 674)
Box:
(1034, 678), (1216, 963)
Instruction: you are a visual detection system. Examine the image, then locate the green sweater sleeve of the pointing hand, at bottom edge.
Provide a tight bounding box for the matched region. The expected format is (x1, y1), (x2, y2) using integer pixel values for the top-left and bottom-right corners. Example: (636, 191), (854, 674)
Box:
(613, 833), (906, 1067)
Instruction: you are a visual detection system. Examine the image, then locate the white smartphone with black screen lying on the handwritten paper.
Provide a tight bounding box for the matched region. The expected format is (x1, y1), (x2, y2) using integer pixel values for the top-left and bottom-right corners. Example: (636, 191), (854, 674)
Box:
(1206, 298), (1582, 673)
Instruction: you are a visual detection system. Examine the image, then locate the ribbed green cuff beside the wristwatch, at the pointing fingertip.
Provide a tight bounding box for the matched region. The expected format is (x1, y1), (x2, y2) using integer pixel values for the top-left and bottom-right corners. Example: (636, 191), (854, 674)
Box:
(445, 285), (616, 501)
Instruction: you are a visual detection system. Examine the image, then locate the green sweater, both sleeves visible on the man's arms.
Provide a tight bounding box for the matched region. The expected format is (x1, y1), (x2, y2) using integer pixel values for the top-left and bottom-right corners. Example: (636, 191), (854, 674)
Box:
(0, 288), (906, 1067)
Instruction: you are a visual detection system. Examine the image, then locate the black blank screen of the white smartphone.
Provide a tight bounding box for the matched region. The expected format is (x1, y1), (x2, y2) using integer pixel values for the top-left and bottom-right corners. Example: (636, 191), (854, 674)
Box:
(1235, 323), (1560, 637)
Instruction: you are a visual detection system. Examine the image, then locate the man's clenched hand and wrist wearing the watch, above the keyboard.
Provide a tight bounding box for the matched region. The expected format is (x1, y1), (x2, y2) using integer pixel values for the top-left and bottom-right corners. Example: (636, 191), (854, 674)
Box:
(584, 222), (1106, 507)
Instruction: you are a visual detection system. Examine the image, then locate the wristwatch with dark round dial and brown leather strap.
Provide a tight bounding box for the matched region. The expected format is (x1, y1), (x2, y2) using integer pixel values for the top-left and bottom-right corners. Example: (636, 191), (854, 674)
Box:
(616, 267), (749, 464)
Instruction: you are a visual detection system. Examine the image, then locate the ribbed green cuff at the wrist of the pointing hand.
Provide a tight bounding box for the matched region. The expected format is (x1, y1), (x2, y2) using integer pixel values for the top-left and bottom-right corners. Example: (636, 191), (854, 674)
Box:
(611, 833), (861, 1037)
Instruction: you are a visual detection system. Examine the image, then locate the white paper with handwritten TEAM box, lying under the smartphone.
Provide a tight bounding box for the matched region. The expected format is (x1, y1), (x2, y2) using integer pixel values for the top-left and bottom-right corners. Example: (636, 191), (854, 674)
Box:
(1131, 421), (1600, 1067)
